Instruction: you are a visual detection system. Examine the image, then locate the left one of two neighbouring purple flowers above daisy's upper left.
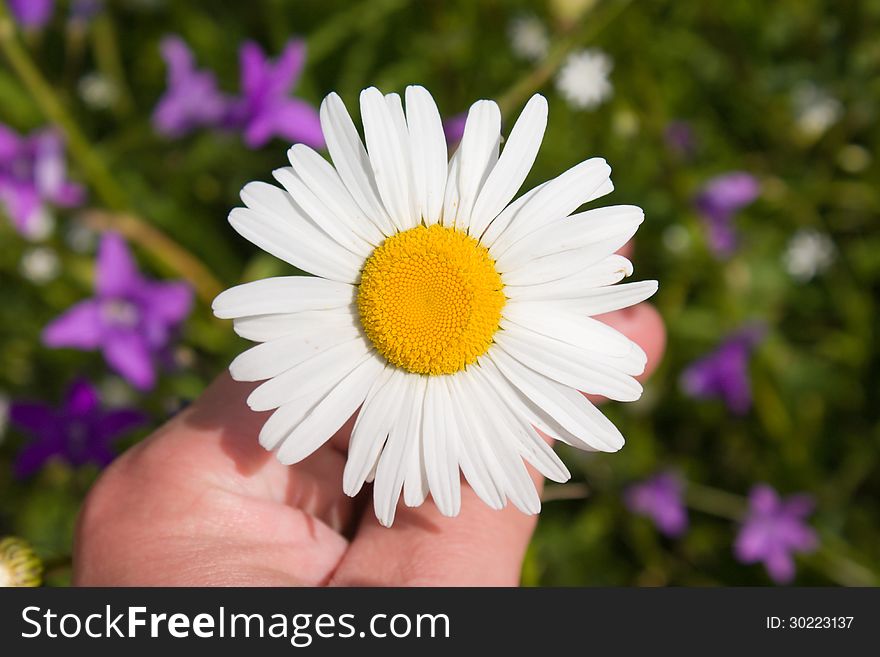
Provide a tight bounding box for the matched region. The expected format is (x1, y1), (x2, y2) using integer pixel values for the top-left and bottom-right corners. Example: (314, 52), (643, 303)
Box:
(153, 36), (229, 138)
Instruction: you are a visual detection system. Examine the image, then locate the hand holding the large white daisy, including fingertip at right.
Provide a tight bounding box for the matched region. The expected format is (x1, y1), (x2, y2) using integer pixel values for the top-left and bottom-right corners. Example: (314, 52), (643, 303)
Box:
(74, 296), (665, 586)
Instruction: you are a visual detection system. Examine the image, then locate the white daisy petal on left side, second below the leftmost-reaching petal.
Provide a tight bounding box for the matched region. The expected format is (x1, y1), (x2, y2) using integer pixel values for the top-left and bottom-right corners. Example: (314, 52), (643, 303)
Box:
(229, 323), (361, 381)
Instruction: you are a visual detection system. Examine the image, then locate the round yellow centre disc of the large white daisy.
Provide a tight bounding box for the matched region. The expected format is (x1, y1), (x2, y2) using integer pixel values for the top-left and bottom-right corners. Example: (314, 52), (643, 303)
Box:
(358, 224), (506, 374)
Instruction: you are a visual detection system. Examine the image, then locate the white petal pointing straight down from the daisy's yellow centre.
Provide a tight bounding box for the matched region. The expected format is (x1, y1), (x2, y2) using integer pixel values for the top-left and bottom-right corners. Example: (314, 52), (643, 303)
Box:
(422, 377), (461, 516)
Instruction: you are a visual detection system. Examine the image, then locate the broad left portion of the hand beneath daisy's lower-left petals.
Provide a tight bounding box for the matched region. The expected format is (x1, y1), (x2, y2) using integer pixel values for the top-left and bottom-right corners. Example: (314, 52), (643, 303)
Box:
(74, 375), (351, 585)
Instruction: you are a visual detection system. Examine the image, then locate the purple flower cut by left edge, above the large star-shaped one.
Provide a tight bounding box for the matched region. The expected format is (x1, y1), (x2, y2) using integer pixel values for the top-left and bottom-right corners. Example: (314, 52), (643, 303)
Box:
(0, 124), (85, 238)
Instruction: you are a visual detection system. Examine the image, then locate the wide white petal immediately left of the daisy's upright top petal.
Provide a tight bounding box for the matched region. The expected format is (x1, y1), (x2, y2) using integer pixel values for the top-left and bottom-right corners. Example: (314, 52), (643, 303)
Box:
(361, 87), (419, 231)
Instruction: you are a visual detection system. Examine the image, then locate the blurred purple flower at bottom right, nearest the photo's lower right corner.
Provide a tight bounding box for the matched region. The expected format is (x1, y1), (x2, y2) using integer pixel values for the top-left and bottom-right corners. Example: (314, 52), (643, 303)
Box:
(733, 484), (818, 584)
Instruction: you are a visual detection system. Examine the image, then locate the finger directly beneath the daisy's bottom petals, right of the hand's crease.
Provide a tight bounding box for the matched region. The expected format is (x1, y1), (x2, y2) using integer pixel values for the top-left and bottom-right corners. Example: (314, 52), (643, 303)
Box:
(330, 467), (543, 586)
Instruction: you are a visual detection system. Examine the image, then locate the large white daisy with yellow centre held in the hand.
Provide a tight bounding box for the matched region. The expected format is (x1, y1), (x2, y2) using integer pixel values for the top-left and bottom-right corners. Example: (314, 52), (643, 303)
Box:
(213, 86), (657, 526)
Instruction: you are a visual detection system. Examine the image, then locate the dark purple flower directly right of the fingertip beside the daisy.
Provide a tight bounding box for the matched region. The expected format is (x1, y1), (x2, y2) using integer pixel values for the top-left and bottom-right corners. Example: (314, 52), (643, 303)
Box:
(681, 326), (764, 415)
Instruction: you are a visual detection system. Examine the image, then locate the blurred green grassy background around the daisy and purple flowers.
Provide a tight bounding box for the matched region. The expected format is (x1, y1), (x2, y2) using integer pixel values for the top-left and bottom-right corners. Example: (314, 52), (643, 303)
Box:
(0, 0), (880, 586)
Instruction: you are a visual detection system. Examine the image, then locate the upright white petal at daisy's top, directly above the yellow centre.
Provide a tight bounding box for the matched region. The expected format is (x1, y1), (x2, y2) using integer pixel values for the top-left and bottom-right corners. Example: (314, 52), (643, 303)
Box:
(406, 86), (447, 226)
